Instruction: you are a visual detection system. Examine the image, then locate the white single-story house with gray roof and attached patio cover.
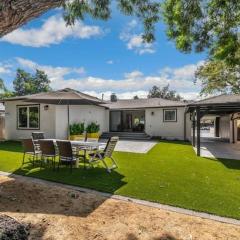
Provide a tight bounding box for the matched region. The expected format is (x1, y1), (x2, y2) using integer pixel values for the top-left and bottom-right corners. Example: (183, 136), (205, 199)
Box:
(2, 88), (240, 157)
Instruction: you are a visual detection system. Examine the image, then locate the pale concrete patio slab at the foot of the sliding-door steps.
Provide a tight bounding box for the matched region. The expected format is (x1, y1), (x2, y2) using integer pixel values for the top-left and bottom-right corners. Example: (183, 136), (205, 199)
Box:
(115, 140), (157, 153)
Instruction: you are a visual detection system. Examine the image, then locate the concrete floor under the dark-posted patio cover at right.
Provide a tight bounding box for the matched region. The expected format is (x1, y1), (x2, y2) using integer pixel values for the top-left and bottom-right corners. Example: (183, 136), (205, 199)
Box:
(194, 141), (240, 160)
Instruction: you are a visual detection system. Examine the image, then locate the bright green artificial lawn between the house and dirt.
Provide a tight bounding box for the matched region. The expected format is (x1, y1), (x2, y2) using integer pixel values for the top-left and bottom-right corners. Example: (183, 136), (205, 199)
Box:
(0, 141), (240, 219)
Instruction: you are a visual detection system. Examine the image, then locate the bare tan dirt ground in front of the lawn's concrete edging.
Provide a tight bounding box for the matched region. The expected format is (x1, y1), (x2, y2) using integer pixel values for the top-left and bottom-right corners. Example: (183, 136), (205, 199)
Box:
(0, 177), (240, 240)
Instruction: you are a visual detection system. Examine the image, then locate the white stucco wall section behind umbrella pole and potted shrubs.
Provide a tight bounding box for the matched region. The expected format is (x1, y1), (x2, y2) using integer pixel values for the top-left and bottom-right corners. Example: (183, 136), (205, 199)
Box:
(56, 105), (109, 139)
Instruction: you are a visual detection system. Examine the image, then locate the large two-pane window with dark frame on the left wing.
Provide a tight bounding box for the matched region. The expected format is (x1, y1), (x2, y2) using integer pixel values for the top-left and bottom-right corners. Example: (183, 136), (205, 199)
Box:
(17, 105), (40, 129)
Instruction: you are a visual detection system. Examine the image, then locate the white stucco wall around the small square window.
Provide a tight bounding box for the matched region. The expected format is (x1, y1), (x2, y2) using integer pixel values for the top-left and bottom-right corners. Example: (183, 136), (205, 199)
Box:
(145, 107), (189, 140)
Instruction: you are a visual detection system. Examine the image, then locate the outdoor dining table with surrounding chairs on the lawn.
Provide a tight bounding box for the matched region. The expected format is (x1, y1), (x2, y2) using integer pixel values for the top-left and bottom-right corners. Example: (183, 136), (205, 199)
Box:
(22, 132), (119, 172)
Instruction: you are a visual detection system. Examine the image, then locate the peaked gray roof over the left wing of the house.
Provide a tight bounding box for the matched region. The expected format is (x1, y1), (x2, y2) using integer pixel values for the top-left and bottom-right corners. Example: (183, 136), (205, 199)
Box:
(2, 88), (104, 104)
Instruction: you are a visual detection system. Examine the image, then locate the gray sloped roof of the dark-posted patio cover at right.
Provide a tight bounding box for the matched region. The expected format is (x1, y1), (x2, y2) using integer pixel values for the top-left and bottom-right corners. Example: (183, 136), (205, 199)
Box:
(189, 94), (240, 106)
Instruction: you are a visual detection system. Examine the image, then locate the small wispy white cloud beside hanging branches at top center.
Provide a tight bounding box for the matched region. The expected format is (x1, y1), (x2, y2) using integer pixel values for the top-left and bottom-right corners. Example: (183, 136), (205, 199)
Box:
(120, 20), (155, 55)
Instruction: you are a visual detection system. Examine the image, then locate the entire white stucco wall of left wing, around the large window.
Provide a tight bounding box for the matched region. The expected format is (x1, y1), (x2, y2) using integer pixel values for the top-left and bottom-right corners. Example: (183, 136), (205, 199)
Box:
(5, 101), (109, 140)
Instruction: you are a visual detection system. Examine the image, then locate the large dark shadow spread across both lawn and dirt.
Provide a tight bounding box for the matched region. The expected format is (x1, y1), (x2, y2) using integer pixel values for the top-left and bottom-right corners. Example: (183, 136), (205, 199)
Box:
(0, 164), (125, 217)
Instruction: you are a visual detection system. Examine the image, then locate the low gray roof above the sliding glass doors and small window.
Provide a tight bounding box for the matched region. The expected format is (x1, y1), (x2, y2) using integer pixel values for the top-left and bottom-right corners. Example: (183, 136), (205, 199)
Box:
(103, 98), (186, 109)
